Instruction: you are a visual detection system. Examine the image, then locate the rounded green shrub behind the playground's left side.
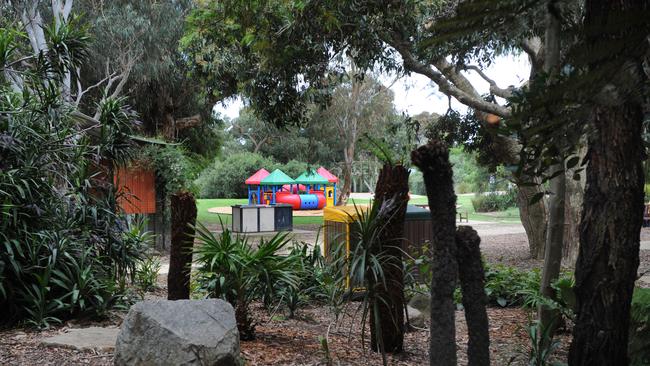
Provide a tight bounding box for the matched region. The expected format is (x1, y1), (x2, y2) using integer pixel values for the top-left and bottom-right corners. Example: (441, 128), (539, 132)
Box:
(196, 152), (276, 198)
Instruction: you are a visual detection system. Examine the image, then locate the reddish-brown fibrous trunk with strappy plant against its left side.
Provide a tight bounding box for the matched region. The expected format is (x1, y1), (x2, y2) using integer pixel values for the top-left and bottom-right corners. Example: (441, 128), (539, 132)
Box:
(368, 164), (409, 353)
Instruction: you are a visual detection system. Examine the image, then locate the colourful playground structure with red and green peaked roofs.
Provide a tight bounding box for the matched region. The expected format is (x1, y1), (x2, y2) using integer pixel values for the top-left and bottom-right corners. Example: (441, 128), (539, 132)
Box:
(245, 167), (338, 210)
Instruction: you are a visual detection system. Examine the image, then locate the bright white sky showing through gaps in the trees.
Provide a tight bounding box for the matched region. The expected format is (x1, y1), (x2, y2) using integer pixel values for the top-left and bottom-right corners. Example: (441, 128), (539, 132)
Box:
(215, 54), (530, 119)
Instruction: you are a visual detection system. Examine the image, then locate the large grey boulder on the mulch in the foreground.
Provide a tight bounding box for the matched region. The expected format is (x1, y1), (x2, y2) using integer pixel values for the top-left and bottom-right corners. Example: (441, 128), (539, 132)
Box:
(115, 299), (239, 366)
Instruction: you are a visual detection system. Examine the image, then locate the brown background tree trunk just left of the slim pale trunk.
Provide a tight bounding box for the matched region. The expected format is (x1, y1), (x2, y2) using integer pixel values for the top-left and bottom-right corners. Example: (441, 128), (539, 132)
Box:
(517, 181), (546, 259)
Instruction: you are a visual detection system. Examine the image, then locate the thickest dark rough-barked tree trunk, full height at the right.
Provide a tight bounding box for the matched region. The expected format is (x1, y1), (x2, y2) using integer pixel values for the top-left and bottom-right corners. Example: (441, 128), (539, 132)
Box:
(569, 0), (650, 366)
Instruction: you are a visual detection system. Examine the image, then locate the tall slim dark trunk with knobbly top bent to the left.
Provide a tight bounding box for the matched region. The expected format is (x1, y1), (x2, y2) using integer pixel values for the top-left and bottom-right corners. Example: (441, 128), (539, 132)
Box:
(411, 140), (458, 366)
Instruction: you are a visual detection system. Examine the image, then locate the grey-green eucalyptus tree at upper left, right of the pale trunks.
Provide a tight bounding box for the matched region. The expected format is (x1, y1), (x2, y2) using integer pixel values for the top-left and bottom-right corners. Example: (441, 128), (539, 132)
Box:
(73, 0), (222, 157)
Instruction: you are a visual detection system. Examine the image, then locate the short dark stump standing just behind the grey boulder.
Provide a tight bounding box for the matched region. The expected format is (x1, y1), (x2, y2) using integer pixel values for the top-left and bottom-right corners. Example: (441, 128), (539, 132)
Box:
(167, 192), (196, 300)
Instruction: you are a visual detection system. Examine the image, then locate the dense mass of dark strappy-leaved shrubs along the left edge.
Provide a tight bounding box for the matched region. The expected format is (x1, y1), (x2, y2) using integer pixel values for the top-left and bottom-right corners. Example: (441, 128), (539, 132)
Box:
(0, 93), (147, 327)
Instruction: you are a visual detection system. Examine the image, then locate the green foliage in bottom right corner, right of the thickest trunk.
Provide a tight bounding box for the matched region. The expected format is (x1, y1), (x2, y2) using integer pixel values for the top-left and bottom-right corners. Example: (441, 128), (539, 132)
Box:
(628, 288), (650, 366)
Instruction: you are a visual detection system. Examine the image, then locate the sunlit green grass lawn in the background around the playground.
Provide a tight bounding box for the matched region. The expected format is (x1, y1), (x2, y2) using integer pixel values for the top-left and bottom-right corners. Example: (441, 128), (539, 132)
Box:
(197, 195), (520, 225)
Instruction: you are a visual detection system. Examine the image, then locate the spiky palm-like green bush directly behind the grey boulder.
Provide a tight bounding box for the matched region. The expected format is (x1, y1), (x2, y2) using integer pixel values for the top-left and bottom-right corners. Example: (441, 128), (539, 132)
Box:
(195, 223), (301, 340)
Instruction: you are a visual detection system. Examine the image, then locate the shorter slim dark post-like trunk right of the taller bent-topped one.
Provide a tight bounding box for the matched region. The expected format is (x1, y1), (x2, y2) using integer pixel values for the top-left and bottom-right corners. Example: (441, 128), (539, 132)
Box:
(456, 226), (490, 366)
